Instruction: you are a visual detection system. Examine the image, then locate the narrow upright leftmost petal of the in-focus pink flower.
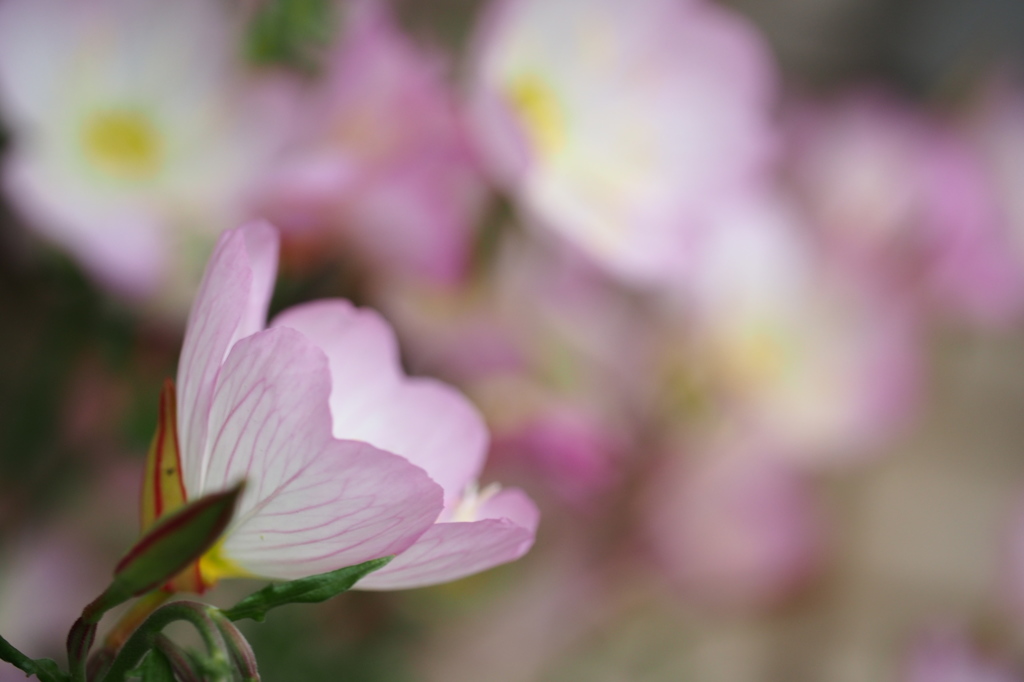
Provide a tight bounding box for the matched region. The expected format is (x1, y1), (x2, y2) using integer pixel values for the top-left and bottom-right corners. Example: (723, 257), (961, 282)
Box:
(177, 222), (278, 497)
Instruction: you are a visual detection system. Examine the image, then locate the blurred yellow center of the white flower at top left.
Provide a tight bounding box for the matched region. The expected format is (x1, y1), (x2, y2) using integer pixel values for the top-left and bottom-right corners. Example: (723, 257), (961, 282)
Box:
(82, 110), (163, 181)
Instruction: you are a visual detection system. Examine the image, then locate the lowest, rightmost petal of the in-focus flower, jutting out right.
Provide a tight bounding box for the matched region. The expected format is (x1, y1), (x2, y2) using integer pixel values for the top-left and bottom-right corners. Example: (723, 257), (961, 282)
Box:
(356, 488), (539, 590)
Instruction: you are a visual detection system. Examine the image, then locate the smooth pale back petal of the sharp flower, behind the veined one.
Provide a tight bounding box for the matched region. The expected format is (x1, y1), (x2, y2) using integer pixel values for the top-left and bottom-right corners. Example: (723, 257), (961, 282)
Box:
(272, 300), (487, 500)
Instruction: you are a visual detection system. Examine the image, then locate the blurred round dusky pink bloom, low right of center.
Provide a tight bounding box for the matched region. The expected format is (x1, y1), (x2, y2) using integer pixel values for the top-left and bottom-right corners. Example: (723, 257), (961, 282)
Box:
(647, 436), (824, 608)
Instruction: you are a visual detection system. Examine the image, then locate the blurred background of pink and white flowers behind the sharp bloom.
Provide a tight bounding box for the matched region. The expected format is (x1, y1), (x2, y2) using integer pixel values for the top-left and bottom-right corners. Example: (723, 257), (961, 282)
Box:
(0, 0), (1024, 682)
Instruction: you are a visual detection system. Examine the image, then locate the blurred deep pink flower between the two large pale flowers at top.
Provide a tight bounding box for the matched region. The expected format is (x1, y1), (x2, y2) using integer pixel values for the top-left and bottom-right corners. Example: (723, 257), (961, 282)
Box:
(262, 2), (483, 284)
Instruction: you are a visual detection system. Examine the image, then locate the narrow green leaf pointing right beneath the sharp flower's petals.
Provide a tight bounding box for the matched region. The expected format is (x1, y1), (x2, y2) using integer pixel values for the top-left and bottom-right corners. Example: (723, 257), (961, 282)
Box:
(224, 556), (394, 621)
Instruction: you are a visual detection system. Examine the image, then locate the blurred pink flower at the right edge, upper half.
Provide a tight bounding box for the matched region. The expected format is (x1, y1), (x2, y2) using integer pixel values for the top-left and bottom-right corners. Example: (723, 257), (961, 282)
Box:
(791, 90), (1024, 324)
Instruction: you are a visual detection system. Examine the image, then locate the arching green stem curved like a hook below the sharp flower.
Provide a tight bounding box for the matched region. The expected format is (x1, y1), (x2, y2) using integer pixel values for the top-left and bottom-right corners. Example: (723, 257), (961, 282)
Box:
(102, 601), (230, 682)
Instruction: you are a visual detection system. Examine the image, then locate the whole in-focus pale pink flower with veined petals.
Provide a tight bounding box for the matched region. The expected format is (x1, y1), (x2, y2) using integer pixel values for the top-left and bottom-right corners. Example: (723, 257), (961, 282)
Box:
(159, 223), (537, 589)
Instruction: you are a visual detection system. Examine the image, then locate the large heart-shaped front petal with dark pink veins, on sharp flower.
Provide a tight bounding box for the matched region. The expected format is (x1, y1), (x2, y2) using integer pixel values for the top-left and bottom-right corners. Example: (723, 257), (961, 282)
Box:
(200, 328), (442, 579)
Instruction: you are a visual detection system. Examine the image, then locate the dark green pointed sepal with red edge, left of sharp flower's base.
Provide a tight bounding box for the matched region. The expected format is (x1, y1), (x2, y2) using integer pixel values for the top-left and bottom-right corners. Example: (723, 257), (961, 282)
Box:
(82, 481), (245, 623)
